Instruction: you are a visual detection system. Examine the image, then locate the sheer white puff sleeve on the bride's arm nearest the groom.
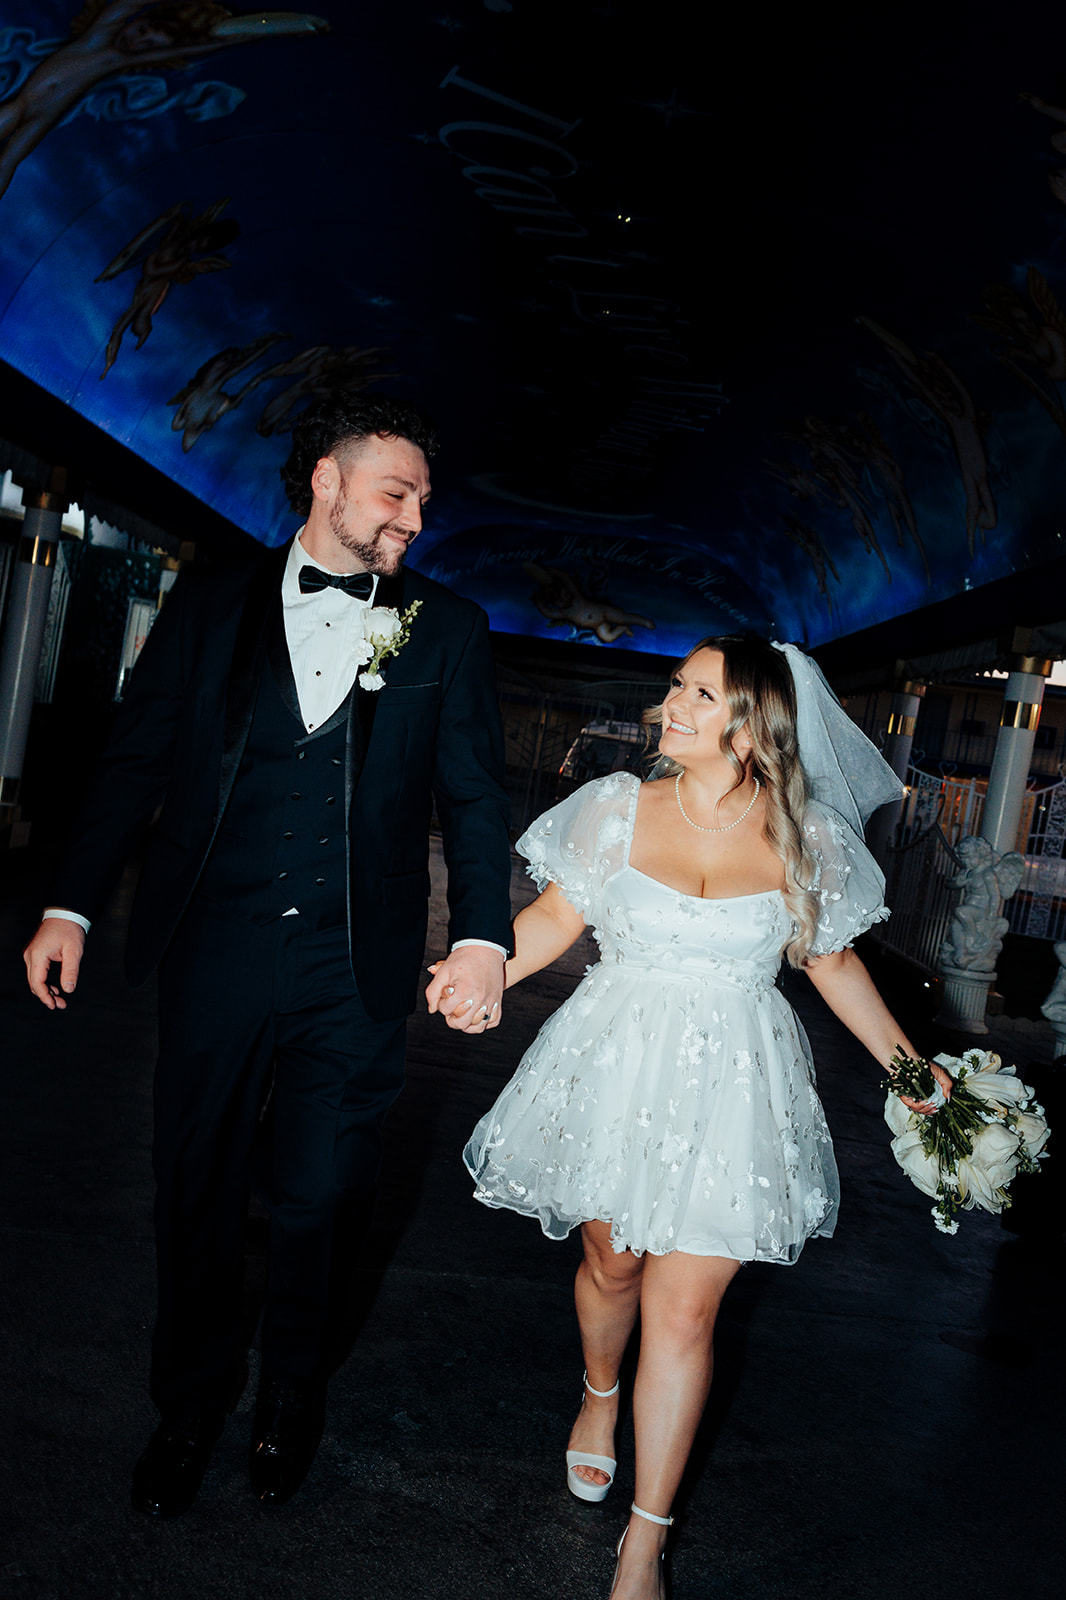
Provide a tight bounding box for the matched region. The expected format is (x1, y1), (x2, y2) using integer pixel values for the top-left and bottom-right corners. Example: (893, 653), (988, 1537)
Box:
(515, 773), (640, 923)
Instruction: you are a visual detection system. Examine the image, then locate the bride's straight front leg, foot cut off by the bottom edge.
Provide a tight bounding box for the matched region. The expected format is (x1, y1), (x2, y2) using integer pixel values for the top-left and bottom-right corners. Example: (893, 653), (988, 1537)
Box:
(610, 1251), (739, 1600)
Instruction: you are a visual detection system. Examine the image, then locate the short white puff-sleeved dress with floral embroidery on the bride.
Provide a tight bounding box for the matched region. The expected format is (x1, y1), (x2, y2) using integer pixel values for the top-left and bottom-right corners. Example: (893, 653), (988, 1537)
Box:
(464, 773), (888, 1262)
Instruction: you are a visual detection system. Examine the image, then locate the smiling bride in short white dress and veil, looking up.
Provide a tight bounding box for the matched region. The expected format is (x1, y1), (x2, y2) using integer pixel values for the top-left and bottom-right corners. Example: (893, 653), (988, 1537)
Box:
(464, 635), (951, 1600)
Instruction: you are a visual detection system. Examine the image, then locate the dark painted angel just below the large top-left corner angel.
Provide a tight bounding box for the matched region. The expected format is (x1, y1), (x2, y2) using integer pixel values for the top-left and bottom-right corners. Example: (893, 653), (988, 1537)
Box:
(96, 197), (240, 379)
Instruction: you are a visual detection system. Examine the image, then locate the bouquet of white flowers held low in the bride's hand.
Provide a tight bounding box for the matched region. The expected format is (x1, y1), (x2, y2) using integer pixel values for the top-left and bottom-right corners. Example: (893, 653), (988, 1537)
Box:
(882, 1050), (1048, 1234)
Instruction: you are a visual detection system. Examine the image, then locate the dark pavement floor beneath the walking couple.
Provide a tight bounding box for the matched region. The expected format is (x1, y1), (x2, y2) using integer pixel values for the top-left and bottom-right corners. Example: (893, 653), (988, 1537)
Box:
(0, 854), (1063, 1600)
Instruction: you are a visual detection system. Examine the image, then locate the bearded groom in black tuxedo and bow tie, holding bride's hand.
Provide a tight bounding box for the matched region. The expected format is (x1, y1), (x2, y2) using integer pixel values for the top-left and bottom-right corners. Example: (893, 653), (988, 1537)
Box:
(26, 394), (511, 1517)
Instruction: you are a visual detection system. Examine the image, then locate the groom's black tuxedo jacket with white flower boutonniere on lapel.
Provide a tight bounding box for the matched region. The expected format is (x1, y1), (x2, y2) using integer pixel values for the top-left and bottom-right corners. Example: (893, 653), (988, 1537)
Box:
(50, 547), (511, 1018)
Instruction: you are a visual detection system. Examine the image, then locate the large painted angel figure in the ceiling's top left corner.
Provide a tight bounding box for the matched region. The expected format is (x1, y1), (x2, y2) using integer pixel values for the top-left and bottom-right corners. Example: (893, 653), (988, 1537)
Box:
(0, 0), (330, 195)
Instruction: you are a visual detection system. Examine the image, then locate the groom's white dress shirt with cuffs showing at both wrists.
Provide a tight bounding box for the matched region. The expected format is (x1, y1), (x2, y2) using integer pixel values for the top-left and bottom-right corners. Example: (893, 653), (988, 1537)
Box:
(43, 528), (507, 957)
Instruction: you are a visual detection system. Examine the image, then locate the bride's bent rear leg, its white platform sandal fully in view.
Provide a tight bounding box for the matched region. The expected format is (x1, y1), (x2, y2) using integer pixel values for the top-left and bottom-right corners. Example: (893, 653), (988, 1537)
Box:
(567, 1222), (643, 1483)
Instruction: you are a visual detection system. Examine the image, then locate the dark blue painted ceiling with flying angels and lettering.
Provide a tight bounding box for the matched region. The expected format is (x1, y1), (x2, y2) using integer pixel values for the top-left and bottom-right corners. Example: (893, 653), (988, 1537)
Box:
(0, 0), (1066, 653)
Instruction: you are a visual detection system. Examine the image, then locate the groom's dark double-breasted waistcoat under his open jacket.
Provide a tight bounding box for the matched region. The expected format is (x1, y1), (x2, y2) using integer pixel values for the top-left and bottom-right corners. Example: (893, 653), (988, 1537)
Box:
(198, 651), (347, 928)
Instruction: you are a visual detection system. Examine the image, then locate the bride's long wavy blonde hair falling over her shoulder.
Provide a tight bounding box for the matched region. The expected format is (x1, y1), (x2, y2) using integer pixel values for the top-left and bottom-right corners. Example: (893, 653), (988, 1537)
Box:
(643, 634), (818, 966)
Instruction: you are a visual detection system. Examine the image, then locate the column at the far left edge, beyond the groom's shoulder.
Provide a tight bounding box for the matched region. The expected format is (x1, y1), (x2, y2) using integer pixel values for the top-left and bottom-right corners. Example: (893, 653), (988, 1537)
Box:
(0, 467), (69, 843)
